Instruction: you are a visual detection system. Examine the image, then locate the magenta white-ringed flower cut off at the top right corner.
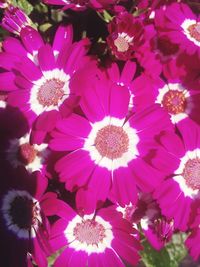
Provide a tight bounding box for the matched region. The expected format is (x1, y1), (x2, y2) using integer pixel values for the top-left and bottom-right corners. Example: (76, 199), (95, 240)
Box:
(156, 3), (200, 55)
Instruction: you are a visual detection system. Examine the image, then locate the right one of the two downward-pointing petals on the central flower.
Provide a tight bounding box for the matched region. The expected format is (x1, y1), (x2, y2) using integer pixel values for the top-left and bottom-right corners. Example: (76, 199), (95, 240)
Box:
(109, 168), (138, 206)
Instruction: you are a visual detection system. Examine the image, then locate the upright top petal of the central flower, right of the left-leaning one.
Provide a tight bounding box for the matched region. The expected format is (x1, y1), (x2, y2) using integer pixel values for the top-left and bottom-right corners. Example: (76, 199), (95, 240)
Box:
(109, 84), (130, 119)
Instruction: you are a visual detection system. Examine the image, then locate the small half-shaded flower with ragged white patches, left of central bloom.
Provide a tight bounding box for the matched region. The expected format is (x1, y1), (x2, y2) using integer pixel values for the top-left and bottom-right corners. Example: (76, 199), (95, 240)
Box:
(6, 134), (50, 172)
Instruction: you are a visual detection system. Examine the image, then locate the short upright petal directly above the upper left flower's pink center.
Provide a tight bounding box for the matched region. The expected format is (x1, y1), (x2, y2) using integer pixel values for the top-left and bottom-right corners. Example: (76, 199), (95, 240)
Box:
(38, 44), (56, 73)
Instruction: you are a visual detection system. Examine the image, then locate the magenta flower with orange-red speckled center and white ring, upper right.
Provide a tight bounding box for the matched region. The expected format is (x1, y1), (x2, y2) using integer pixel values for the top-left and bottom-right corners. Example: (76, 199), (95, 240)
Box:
(133, 70), (200, 124)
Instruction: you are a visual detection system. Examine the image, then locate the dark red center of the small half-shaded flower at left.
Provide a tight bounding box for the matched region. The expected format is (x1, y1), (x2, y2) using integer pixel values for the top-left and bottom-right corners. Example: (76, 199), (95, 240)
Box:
(18, 143), (38, 165)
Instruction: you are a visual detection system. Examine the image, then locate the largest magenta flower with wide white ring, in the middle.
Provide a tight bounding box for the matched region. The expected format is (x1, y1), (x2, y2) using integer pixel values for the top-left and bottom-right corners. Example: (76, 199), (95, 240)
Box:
(50, 66), (171, 205)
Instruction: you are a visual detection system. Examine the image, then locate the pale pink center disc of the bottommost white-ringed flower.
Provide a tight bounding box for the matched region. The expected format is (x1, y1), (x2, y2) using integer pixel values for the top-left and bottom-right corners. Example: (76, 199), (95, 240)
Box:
(74, 220), (105, 246)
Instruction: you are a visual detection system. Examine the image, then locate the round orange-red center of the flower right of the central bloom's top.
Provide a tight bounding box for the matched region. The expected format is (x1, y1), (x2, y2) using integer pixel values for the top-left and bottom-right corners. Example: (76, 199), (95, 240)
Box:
(162, 90), (187, 115)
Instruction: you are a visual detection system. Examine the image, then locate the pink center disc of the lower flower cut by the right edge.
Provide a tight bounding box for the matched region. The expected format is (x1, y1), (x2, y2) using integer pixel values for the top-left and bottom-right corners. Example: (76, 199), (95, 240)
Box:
(183, 158), (200, 190)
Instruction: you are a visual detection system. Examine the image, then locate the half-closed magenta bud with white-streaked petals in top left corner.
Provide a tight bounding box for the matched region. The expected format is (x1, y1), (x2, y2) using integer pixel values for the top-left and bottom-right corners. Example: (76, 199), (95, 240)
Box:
(1, 5), (32, 34)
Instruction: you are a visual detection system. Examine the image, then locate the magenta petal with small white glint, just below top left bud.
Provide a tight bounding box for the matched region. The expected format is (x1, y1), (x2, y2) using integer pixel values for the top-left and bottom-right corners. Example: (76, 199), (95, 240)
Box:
(20, 26), (44, 54)
